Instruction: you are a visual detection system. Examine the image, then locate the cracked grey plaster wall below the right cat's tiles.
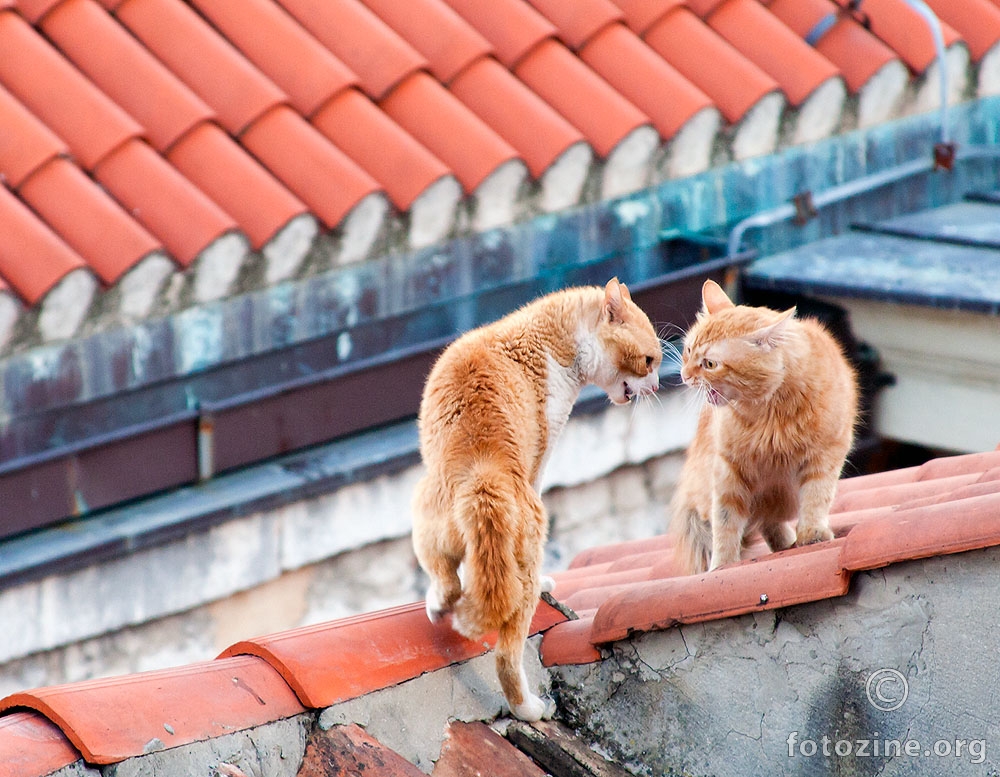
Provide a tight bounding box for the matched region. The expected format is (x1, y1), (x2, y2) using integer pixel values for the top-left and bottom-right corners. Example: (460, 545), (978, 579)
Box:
(553, 548), (1000, 776)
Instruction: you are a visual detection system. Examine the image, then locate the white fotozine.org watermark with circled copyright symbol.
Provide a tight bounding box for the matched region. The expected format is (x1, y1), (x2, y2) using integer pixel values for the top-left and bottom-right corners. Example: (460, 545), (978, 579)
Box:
(786, 669), (986, 764)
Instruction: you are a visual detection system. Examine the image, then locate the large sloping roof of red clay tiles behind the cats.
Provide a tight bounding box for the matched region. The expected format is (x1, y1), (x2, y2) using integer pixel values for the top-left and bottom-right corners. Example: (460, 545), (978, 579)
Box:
(0, 0), (988, 349)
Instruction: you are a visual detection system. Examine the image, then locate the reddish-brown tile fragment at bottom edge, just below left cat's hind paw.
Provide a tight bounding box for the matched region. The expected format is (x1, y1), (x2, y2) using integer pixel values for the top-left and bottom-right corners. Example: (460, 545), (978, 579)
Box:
(432, 720), (546, 777)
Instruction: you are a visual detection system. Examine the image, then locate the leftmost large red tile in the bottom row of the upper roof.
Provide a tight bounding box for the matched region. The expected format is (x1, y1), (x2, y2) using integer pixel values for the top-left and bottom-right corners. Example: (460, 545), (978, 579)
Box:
(0, 186), (87, 305)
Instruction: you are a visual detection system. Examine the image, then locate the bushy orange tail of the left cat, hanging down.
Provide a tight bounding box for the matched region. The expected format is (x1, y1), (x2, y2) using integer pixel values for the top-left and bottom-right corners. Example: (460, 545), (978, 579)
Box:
(452, 462), (531, 638)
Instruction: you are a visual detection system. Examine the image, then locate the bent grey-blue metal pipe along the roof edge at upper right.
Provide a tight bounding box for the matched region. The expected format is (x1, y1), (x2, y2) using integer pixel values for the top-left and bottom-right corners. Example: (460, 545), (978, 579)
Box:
(727, 0), (968, 256)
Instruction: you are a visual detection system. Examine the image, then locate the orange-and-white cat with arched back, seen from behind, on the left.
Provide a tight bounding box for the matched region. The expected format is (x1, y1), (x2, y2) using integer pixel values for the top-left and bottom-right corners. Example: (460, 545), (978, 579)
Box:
(413, 278), (662, 720)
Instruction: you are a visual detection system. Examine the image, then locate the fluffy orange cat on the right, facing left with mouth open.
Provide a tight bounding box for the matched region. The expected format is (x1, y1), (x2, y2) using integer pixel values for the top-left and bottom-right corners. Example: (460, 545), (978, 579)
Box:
(671, 280), (858, 574)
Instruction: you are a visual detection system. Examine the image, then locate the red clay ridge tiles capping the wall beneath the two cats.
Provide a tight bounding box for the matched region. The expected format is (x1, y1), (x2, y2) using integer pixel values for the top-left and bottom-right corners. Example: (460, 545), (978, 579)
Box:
(0, 448), (1000, 777)
